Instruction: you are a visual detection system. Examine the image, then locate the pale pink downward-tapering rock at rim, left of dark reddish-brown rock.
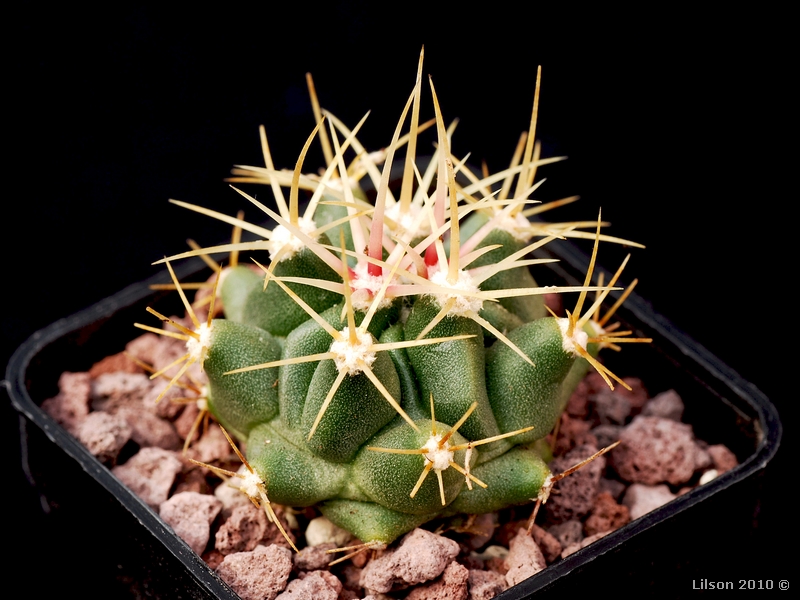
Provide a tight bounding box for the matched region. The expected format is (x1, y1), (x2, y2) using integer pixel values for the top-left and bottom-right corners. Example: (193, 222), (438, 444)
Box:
(158, 492), (222, 554)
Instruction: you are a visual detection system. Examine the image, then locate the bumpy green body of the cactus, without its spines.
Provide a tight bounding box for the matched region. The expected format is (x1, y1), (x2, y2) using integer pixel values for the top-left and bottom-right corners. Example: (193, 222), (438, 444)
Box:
(204, 224), (600, 543)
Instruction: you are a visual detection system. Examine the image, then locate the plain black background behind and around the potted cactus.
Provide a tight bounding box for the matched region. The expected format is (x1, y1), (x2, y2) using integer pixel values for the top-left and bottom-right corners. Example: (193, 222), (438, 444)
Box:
(2, 2), (797, 600)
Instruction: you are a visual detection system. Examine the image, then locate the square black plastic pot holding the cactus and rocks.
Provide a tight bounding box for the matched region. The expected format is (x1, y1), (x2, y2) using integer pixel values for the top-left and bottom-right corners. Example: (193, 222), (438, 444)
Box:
(6, 238), (781, 600)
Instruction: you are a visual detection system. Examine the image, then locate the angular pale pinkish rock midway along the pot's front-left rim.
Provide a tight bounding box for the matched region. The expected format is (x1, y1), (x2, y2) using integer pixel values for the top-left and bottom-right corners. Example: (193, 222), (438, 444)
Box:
(112, 448), (181, 510)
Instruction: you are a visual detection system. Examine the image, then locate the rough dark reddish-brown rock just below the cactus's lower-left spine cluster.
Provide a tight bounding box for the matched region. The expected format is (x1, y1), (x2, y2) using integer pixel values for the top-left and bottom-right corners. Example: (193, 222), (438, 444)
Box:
(214, 502), (296, 552)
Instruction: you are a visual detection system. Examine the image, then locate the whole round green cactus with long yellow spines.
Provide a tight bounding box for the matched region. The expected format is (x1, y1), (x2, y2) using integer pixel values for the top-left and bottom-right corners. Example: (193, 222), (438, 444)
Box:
(141, 51), (643, 547)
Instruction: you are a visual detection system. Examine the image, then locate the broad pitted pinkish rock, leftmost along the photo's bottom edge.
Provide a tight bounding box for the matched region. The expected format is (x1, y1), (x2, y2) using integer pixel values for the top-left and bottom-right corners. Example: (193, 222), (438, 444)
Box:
(216, 544), (292, 600)
